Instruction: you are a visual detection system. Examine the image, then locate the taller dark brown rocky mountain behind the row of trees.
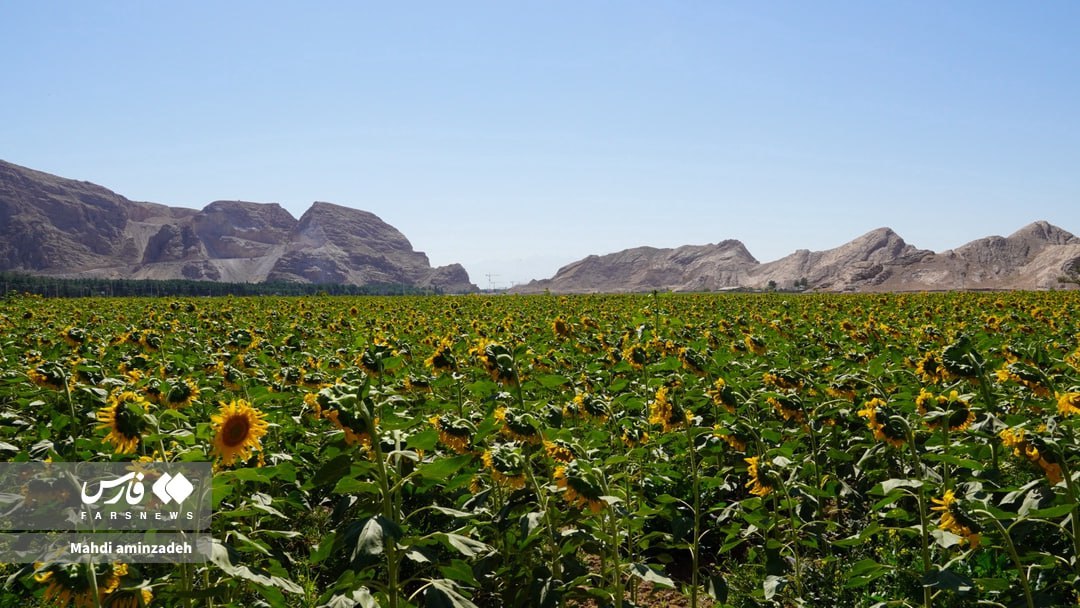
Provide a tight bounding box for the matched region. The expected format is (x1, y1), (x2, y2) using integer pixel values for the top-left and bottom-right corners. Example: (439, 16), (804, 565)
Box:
(0, 161), (477, 293)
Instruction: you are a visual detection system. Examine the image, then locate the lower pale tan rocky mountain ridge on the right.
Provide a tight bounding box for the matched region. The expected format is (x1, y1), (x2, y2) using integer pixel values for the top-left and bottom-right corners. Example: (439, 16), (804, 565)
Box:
(514, 221), (1080, 294)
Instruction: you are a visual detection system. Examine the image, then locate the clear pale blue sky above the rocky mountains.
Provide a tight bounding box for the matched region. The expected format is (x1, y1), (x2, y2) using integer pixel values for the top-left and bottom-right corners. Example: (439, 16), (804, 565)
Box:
(0, 0), (1080, 286)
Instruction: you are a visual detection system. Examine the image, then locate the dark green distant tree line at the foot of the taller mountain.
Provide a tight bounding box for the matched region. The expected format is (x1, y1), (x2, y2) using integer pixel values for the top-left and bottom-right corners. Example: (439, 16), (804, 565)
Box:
(0, 272), (442, 298)
